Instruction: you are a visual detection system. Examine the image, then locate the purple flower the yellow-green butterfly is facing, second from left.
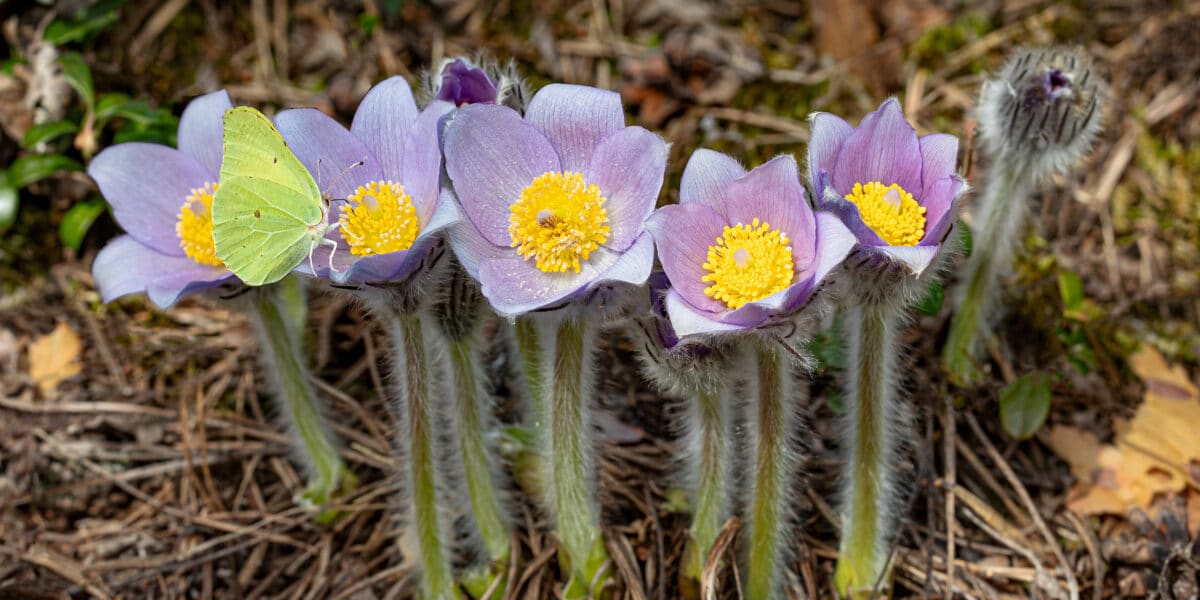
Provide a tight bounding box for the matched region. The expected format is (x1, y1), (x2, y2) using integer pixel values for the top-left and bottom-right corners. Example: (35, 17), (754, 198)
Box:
(275, 77), (458, 283)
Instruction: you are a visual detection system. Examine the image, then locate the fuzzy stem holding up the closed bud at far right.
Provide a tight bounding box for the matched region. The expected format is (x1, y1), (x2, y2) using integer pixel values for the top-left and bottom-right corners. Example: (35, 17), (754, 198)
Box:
(942, 164), (1031, 385)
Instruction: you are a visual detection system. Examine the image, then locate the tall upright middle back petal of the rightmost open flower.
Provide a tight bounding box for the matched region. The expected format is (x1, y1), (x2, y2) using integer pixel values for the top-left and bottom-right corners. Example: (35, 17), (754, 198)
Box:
(833, 98), (922, 194)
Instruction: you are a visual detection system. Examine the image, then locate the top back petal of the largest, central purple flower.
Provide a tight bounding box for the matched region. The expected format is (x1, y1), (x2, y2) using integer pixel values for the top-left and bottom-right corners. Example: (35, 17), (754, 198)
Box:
(526, 83), (625, 173)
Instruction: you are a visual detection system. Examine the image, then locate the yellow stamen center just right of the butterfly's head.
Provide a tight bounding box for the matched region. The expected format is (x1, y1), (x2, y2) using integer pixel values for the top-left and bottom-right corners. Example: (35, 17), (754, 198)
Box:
(337, 181), (420, 257)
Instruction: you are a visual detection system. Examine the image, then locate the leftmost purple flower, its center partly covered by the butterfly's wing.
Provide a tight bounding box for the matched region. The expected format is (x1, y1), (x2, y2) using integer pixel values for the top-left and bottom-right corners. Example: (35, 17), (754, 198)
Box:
(88, 90), (234, 308)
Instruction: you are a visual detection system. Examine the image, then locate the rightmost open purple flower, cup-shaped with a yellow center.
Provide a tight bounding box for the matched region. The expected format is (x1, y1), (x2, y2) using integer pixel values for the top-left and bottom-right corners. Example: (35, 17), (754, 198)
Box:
(809, 98), (966, 275)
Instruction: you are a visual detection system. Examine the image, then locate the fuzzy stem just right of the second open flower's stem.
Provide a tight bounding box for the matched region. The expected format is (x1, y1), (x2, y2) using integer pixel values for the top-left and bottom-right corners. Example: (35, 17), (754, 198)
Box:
(450, 337), (511, 562)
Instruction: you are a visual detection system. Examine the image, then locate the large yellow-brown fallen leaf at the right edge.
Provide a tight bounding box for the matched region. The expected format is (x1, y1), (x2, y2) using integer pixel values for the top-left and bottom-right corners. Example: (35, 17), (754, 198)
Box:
(1044, 347), (1200, 515)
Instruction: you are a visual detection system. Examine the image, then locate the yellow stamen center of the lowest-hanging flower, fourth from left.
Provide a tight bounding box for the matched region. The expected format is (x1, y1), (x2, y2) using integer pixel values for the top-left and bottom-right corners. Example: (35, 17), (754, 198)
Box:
(701, 218), (796, 310)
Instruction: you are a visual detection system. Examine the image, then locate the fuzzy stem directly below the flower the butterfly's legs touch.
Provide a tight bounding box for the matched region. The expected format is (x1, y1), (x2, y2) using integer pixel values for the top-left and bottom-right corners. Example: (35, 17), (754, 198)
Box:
(385, 314), (462, 600)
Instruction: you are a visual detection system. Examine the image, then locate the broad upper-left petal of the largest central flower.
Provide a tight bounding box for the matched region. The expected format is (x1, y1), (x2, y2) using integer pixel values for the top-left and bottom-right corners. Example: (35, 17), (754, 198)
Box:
(445, 104), (559, 246)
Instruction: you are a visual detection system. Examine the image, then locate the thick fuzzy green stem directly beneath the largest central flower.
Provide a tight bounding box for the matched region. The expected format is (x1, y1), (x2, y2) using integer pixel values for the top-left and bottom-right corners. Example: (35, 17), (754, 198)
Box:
(534, 313), (607, 598)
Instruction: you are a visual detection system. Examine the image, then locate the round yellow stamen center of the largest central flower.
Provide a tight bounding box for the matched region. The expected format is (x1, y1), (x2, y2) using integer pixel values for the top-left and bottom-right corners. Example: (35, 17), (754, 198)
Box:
(509, 172), (608, 272)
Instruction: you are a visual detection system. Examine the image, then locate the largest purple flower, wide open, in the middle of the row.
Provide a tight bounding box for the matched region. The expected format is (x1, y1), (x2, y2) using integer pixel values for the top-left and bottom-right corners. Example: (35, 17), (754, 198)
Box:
(445, 84), (667, 316)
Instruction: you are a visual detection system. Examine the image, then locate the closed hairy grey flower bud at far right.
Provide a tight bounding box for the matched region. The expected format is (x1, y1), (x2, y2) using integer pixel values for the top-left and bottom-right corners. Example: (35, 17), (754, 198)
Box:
(979, 47), (1108, 179)
